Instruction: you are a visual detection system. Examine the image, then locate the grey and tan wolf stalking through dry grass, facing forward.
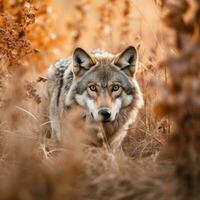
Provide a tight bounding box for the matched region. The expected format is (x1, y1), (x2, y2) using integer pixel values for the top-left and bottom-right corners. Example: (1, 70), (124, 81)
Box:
(47, 46), (143, 151)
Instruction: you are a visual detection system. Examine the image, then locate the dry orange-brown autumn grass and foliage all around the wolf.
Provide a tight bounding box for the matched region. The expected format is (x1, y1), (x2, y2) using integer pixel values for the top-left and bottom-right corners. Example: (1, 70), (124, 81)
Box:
(0, 0), (200, 200)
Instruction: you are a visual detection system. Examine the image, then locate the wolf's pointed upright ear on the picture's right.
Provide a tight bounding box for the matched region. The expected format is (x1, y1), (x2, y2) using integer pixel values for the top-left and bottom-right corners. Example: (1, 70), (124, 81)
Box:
(114, 46), (137, 77)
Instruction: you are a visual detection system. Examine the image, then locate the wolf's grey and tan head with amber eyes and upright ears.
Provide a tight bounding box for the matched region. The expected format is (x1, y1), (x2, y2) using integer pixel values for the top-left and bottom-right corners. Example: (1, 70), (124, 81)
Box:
(69, 46), (143, 122)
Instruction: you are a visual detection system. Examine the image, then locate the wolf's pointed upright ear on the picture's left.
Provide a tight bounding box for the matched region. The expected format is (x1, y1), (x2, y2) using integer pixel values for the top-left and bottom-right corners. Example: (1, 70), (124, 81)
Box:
(73, 47), (95, 75)
